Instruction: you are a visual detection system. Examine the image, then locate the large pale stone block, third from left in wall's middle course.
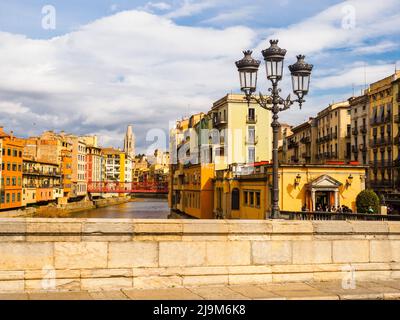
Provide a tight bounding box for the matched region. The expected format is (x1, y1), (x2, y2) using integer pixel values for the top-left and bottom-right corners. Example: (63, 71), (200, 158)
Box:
(108, 241), (158, 268)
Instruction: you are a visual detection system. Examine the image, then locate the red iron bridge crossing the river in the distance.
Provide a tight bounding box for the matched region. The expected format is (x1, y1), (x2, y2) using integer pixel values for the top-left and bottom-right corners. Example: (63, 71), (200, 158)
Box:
(87, 181), (168, 194)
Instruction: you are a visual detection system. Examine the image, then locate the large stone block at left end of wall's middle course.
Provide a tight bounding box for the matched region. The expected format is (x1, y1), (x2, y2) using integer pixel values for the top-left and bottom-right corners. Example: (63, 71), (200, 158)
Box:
(0, 242), (53, 270)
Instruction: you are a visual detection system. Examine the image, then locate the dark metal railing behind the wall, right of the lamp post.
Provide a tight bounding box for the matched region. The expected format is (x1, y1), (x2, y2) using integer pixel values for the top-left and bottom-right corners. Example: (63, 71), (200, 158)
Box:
(281, 211), (400, 221)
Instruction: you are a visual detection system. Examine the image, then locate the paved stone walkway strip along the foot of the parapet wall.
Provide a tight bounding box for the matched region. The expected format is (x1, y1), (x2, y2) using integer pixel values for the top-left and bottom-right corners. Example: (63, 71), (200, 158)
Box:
(0, 280), (400, 300)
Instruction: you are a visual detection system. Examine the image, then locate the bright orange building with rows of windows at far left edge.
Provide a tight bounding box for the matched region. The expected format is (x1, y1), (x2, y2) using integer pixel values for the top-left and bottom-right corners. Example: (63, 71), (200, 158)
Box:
(0, 127), (24, 210)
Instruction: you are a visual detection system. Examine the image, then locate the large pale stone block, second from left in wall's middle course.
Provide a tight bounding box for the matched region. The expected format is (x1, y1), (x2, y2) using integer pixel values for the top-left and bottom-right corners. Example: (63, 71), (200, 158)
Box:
(54, 242), (108, 269)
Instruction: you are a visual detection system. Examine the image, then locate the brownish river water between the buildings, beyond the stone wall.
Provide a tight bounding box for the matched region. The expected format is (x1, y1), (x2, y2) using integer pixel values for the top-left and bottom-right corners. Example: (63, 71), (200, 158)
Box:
(71, 199), (170, 219)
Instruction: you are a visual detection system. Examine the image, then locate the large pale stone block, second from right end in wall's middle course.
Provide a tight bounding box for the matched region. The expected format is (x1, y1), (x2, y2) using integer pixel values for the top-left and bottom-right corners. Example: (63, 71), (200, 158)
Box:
(332, 240), (369, 263)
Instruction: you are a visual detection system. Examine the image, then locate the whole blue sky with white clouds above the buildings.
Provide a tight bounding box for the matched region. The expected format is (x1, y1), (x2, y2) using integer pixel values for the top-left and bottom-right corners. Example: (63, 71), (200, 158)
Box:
(0, 0), (400, 151)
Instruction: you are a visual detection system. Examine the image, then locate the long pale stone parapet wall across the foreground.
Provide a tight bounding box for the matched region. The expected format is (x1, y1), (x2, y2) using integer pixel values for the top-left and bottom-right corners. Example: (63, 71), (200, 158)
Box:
(0, 218), (400, 292)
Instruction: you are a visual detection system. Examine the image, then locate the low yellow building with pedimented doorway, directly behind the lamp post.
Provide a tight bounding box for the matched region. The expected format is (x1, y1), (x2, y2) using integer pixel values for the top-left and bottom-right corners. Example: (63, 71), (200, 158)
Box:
(214, 164), (366, 219)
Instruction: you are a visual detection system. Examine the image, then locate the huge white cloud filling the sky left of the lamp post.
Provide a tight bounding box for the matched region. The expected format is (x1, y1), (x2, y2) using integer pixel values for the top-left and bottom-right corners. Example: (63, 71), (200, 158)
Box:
(0, 11), (255, 151)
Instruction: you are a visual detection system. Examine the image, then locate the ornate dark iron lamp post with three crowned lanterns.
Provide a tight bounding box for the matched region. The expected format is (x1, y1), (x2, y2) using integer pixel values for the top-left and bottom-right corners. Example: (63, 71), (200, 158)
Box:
(236, 40), (313, 219)
